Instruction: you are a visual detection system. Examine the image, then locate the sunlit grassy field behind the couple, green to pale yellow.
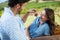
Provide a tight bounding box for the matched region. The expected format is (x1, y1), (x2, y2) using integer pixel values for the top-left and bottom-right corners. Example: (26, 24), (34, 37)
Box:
(0, 1), (60, 27)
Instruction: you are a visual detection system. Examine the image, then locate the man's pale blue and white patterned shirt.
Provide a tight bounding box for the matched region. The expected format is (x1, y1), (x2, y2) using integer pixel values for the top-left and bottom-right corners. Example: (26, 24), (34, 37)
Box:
(0, 8), (27, 40)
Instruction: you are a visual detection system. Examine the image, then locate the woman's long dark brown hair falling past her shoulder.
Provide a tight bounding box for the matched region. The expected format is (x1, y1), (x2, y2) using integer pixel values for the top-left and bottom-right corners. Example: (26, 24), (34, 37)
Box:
(44, 8), (55, 35)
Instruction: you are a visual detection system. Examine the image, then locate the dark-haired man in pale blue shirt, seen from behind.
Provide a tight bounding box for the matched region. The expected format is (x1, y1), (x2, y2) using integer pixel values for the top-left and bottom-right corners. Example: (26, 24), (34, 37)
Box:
(0, 0), (35, 40)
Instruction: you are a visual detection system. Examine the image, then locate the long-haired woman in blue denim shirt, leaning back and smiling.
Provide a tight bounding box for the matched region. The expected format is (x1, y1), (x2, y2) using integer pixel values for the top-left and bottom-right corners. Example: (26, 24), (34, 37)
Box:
(26, 8), (55, 38)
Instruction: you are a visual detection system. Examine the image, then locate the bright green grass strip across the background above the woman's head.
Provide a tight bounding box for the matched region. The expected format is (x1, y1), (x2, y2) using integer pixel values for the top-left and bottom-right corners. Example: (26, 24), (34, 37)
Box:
(26, 1), (60, 9)
